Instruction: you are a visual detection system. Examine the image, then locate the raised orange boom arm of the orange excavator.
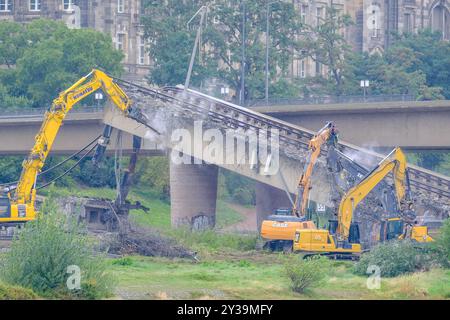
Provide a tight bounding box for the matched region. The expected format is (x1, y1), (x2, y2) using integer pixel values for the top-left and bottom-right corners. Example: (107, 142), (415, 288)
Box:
(292, 122), (336, 217)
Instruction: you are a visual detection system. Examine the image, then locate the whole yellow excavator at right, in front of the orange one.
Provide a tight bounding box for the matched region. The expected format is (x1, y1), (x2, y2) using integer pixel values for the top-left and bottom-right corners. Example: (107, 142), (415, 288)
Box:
(293, 148), (432, 258)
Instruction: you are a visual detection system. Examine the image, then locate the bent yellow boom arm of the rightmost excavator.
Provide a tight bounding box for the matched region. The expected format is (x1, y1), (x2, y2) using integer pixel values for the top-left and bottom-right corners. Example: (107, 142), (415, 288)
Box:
(337, 148), (406, 240)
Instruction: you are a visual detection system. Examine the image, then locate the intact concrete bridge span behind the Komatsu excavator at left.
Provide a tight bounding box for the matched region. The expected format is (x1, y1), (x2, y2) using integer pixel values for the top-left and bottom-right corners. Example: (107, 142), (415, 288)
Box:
(0, 109), (164, 156)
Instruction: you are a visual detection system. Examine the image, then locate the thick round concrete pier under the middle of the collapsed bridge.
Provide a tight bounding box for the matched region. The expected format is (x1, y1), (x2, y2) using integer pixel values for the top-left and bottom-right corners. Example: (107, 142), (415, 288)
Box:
(170, 162), (218, 230)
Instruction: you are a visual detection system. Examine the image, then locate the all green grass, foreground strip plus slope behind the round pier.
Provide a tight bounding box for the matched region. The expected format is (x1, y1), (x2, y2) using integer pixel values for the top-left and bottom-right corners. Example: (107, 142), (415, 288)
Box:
(40, 185), (450, 299)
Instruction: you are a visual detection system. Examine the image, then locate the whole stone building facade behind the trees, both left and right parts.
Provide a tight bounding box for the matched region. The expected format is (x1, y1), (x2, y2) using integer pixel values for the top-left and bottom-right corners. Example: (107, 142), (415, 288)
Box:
(0, 0), (450, 80)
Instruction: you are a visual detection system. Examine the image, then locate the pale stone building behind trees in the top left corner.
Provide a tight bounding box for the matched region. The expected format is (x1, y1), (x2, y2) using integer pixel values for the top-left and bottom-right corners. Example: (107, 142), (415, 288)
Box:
(0, 0), (150, 80)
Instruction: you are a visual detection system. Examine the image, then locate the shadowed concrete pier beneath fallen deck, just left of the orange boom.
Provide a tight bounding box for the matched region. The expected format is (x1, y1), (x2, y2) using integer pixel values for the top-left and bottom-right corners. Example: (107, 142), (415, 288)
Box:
(255, 182), (292, 232)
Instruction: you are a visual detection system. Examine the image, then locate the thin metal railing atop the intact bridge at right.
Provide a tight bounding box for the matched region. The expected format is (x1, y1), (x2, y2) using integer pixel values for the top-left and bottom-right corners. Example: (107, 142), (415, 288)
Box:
(245, 94), (416, 107)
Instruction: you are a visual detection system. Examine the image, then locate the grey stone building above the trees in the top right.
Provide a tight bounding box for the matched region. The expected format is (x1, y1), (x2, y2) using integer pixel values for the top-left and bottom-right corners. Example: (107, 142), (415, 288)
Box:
(286, 0), (450, 78)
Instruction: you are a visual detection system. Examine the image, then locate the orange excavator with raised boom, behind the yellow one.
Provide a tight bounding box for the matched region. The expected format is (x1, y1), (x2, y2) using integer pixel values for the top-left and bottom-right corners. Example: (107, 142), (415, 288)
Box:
(261, 122), (338, 251)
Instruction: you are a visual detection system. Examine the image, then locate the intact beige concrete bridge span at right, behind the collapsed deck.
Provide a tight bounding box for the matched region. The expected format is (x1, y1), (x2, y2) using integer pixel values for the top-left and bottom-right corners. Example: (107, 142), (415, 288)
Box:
(252, 100), (450, 150)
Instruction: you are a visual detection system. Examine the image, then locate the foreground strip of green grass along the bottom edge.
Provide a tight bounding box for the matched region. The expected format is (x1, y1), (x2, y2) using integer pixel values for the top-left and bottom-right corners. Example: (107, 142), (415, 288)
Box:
(112, 253), (450, 300)
